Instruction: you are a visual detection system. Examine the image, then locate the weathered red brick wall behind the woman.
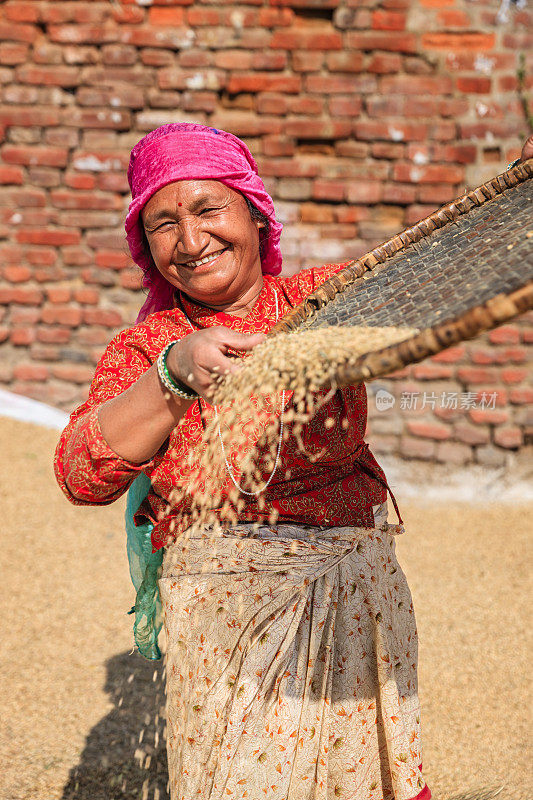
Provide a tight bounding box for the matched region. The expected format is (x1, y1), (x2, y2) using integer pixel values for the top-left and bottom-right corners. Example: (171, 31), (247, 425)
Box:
(0, 0), (533, 463)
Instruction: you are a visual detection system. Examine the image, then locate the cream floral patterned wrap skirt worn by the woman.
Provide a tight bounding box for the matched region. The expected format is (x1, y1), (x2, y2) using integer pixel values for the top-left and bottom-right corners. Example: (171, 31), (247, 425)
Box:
(160, 504), (431, 800)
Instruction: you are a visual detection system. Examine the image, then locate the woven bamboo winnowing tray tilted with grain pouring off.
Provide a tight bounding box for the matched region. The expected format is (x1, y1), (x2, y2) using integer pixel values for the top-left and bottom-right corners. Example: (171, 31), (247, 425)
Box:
(270, 159), (533, 384)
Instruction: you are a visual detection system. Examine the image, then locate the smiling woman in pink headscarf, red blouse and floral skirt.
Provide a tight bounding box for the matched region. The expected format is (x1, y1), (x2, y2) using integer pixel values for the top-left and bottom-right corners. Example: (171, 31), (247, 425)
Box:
(55, 124), (528, 800)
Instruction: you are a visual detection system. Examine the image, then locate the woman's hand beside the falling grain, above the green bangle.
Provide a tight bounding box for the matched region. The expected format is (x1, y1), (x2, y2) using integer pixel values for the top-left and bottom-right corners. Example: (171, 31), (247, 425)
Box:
(167, 326), (265, 398)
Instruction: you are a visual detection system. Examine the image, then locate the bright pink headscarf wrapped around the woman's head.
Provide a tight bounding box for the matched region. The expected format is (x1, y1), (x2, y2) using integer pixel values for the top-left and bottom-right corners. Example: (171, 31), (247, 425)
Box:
(126, 122), (282, 322)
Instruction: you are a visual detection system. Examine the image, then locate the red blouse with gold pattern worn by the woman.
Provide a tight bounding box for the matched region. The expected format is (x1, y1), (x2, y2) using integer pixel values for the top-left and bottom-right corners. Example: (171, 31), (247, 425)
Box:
(54, 264), (401, 550)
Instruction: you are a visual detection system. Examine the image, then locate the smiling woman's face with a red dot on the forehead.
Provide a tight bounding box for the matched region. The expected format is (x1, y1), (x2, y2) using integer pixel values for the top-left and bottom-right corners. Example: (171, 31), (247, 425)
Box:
(142, 180), (262, 310)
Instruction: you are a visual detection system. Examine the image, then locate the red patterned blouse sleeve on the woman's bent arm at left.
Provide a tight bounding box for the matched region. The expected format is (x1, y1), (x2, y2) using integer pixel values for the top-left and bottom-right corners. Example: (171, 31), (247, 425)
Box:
(54, 330), (163, 505)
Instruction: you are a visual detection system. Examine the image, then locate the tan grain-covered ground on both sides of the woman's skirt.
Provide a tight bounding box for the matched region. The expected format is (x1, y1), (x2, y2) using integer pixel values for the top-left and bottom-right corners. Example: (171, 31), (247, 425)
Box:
(0, 418), (533, 800)
